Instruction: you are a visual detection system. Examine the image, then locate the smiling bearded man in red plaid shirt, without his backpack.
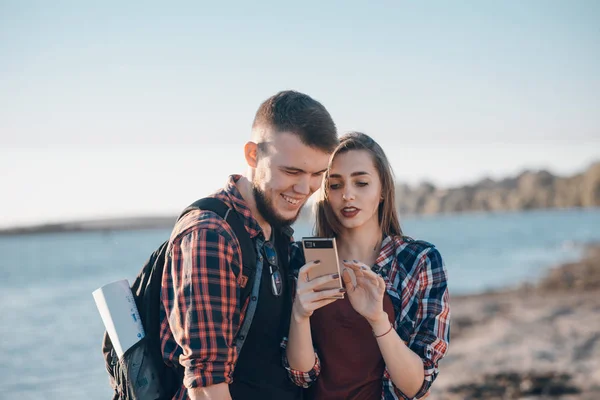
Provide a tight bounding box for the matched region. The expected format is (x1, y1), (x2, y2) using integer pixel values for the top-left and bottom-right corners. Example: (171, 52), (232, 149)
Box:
(161, 91), (338, 400)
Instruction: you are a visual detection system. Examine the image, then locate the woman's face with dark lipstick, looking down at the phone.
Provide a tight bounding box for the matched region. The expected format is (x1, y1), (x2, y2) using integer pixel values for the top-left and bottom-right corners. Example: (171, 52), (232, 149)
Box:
(327, 150), (381, 229)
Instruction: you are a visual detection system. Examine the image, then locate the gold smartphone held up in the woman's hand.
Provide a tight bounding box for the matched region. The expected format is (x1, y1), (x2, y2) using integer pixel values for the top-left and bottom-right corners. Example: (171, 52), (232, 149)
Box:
(302, 237), (343, 290)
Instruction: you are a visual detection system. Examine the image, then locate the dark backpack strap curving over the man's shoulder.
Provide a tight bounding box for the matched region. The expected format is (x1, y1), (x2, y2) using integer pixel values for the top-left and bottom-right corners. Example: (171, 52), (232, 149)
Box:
(179, 197), (256, 304)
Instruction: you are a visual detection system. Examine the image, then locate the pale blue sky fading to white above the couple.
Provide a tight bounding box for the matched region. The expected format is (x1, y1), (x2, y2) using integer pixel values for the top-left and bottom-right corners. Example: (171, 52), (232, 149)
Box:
(0, 0), (600, 227)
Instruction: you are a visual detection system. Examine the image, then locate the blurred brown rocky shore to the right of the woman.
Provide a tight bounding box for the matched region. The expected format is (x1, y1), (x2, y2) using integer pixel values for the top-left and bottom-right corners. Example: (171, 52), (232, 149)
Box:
(428, 244), (600, 400)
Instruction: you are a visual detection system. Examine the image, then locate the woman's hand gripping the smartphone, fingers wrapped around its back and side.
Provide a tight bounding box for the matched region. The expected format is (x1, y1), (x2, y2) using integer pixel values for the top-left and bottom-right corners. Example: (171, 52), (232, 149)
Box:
(292, 260), (346, 322)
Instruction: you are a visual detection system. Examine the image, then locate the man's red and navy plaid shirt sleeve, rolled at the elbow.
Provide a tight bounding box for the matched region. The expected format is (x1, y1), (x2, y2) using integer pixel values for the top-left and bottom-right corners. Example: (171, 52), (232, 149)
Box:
(163, 229), (240, 388)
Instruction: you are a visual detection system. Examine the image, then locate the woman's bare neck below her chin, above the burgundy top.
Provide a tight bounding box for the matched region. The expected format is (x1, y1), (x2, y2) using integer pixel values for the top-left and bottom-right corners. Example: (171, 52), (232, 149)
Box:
(336, 220), (382, 265)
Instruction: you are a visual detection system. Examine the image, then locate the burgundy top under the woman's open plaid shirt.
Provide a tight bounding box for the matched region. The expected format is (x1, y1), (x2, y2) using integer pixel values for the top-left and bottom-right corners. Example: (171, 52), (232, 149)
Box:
(306, 293), (395, 400)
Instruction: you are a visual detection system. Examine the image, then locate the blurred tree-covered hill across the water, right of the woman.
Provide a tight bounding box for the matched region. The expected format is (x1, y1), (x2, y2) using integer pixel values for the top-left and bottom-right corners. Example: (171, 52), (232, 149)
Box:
(396, 162), (600, 215)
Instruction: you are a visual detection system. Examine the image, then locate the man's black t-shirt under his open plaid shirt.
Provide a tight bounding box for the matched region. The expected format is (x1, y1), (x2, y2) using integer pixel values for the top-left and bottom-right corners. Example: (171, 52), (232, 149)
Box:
(229, 238), (302, 400)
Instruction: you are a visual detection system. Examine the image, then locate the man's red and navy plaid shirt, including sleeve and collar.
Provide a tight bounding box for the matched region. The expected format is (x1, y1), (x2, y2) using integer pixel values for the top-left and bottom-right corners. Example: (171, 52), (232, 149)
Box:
(160, 175), (262, 399)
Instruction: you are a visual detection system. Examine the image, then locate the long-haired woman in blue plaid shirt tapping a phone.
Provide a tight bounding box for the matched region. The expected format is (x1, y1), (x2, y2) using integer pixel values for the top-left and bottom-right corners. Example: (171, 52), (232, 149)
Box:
(284, 133), (450, 399)
